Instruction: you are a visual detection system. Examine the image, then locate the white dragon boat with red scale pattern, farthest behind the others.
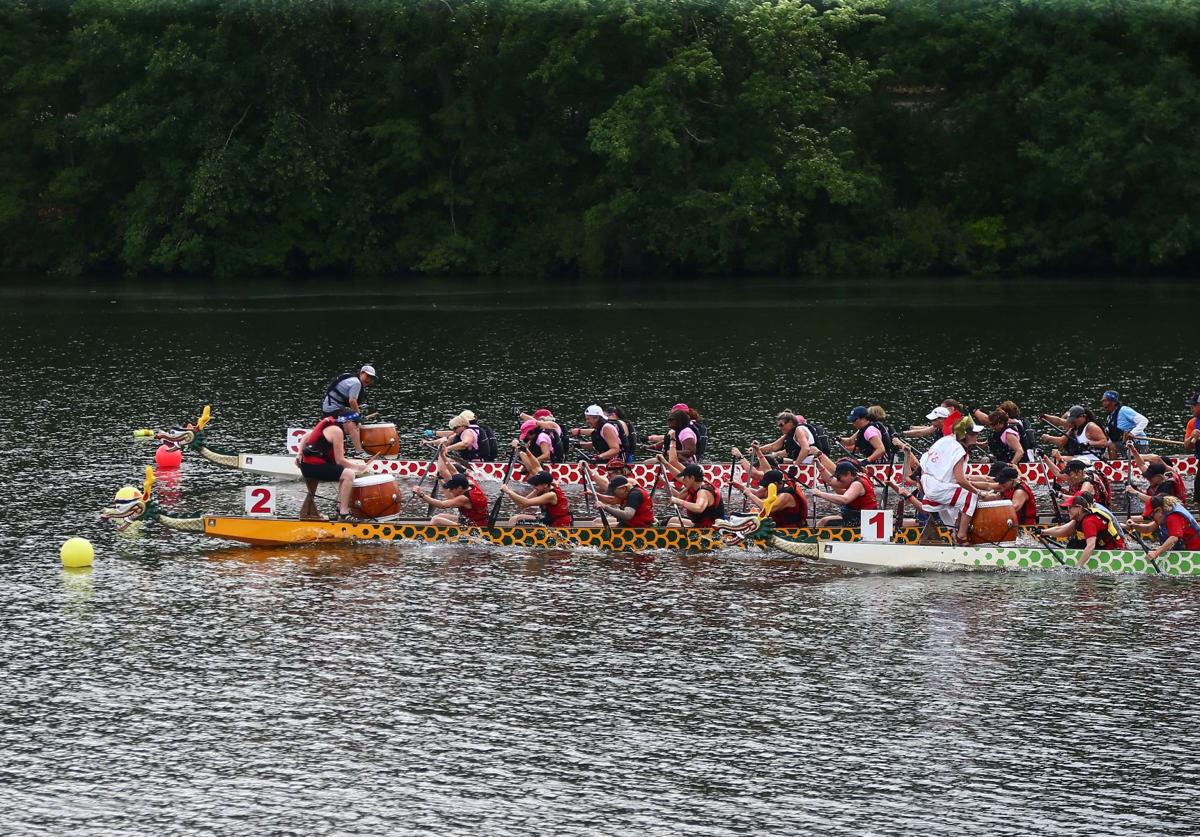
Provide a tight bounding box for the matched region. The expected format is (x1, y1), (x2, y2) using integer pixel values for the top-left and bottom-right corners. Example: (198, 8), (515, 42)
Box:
(134, 407), (1196, 486)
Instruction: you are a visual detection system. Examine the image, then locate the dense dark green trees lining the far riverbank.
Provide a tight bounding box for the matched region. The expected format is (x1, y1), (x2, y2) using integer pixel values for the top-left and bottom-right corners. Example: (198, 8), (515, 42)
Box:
(0, 0), (1200, 275)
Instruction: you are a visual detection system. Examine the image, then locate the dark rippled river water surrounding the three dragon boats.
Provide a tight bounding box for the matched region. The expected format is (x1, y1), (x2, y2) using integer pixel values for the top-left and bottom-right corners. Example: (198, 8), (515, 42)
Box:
(0, 282), (1200, 835)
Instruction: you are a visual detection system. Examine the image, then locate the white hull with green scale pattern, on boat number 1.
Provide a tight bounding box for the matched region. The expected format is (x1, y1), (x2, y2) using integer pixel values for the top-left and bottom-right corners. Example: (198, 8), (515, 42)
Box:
(817, 538), (1200, 576)
